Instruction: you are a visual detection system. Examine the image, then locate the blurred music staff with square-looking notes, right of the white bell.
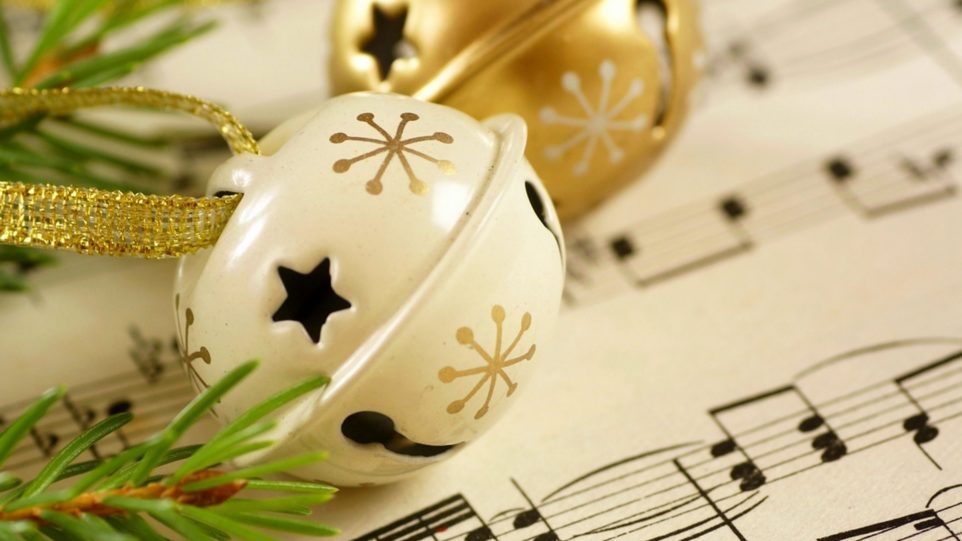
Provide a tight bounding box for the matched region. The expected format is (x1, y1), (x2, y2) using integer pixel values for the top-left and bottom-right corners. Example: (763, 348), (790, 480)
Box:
(565, 102), (962, 304)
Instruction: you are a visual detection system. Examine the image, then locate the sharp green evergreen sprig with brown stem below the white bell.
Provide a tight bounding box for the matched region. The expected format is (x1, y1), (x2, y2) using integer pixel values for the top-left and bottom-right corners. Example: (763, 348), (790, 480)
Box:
(0, 362), (337, 541)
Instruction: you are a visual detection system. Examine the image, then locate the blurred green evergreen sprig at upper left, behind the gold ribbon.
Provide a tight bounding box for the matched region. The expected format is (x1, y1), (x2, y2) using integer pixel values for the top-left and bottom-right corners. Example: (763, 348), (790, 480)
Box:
(0, 0), (214, 292)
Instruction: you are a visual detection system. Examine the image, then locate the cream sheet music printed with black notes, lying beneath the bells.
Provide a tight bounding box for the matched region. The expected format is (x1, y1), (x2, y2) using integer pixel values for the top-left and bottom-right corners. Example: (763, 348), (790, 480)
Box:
(0, 0), (962, 541)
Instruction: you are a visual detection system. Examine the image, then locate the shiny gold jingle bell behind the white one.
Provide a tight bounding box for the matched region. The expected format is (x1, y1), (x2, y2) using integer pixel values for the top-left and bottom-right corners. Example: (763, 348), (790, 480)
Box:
(330, 0), (703, 219)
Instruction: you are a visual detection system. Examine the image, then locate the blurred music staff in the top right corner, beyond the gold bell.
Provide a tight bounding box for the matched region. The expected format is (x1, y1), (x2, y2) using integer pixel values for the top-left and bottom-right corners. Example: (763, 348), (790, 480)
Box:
(706, 0), (962, 89)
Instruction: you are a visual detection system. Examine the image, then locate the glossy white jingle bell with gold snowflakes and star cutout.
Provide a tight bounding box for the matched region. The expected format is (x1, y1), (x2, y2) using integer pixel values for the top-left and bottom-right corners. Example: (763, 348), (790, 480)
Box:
(175, 93), (564, 485)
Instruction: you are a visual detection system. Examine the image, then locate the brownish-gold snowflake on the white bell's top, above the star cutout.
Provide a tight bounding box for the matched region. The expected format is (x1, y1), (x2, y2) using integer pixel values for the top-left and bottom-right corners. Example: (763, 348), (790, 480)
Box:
(331, 113), (455, 195)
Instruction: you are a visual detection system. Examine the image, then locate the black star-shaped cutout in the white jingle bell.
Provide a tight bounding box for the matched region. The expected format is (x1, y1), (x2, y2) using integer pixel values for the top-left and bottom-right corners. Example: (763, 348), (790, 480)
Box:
(273, 258), (351, 344)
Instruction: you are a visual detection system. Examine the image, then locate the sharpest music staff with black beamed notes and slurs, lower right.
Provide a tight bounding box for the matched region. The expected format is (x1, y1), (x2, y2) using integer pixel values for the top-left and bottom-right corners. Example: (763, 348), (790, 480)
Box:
(359, 339), (962, 541)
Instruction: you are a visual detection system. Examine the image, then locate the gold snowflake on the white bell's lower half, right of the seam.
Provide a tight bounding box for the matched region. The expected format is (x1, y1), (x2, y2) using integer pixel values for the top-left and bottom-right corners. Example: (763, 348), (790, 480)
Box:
(438, 304), (535, 419)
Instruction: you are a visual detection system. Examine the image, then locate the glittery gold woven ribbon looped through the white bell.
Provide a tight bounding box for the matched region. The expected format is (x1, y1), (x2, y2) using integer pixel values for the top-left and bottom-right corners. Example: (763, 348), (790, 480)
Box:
(0, 87), (260, 258)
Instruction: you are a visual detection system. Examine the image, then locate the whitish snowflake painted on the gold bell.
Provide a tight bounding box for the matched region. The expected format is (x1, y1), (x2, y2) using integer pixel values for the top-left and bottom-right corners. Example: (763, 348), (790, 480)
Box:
(540, 59), (648, 175)
